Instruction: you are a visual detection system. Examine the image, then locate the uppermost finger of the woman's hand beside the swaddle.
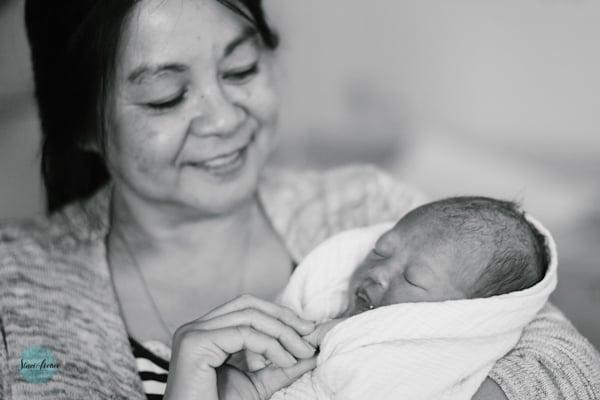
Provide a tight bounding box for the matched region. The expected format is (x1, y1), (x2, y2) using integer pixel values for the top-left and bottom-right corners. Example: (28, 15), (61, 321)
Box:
(199, 295), (315, 335)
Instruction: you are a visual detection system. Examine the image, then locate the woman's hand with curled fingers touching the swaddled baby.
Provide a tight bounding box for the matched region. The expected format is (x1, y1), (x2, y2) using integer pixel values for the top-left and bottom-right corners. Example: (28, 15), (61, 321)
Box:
(159, 296), (316, 400)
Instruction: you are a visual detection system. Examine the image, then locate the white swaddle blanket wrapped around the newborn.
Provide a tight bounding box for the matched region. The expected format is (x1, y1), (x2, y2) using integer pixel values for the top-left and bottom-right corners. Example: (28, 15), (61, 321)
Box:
(272, 218), (557, 400)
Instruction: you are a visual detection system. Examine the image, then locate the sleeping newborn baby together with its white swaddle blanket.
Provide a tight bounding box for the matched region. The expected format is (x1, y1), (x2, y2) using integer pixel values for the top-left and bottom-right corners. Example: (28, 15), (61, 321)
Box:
(272, 197), (556, 400)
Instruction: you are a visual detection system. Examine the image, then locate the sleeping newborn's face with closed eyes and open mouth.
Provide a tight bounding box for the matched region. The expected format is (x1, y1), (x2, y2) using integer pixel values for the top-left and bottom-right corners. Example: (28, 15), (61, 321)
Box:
(344, 214), (467, 316)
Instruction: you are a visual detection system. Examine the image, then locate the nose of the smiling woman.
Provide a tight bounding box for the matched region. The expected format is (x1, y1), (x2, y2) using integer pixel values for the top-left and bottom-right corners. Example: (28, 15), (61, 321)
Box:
(190, 84), (246, 137)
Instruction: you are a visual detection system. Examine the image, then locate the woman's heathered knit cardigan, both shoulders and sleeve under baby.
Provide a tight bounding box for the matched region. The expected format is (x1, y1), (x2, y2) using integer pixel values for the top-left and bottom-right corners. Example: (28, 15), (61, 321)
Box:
(0, 167), (600, 400)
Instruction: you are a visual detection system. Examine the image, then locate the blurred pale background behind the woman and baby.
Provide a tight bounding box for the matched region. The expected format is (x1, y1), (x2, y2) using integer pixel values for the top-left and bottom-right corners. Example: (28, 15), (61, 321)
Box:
(0, 0), (600, 346)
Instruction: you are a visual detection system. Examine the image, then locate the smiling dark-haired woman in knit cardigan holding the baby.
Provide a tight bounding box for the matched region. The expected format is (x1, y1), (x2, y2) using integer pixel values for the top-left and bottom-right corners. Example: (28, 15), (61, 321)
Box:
(0, 0), (600, 399)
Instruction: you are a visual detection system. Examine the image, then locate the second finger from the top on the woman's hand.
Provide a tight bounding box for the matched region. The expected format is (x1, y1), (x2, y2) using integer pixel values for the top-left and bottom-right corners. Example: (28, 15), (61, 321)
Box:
(196, 308), (315, 358)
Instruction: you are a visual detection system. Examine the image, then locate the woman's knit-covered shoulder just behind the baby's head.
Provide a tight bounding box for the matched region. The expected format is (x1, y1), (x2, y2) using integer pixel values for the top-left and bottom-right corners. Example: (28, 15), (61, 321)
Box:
(259, 165), (424, 259)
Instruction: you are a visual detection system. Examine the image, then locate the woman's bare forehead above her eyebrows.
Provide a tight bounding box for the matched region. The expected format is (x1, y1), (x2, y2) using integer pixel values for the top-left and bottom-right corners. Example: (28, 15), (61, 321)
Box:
(121, 0), (249, 73)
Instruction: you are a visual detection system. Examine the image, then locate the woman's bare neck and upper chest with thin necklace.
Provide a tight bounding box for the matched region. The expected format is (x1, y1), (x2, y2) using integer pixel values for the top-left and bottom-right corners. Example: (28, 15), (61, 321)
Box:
(108, 184), (291, 340)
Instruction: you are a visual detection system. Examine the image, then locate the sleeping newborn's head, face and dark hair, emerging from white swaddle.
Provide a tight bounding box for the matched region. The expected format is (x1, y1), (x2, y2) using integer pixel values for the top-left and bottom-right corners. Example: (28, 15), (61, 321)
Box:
(343, 197), (545, 317)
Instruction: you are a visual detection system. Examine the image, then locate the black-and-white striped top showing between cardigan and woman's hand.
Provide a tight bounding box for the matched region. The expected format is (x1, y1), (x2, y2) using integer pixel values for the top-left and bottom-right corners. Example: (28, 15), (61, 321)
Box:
(129, 337), (169, 400)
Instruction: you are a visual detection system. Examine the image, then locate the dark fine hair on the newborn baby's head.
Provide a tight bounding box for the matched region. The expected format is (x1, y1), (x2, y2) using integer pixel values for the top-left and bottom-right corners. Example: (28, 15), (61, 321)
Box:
(415, 196), (548, 298)
